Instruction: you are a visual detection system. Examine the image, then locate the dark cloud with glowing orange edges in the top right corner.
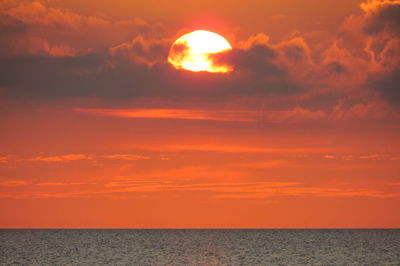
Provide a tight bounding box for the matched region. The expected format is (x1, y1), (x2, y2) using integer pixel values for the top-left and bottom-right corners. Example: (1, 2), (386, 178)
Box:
(345, 0), (400, 104)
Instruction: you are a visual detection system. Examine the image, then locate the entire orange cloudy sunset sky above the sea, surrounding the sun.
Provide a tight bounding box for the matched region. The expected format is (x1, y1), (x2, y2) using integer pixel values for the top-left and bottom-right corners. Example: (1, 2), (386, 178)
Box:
(0, 0), (400, 228)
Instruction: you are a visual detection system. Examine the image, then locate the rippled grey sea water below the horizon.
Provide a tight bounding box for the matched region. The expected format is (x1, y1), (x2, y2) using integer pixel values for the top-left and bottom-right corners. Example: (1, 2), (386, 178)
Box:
(0, 229), (400, 265)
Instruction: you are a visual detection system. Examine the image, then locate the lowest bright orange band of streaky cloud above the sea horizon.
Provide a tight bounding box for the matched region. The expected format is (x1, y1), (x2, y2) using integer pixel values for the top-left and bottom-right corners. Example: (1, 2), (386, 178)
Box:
(0, 179), (400, 199)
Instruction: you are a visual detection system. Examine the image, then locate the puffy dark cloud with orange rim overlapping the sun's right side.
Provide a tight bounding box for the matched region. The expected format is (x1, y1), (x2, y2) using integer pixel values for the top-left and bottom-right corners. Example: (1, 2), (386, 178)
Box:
(212, 33), (303, 95)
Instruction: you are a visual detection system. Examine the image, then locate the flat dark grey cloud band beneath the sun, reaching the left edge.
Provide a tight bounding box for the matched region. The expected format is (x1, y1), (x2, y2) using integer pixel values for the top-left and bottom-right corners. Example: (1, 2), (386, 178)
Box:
(0, 47), (297, 100)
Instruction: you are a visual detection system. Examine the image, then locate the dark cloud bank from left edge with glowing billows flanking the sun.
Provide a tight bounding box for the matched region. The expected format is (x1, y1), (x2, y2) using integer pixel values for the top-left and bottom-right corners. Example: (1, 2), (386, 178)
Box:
(0, 13), (300, 103)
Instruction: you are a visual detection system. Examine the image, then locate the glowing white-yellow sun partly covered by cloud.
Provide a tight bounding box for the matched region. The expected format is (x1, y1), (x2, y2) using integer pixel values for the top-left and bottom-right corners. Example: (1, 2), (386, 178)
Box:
(168, 30), (232, 73)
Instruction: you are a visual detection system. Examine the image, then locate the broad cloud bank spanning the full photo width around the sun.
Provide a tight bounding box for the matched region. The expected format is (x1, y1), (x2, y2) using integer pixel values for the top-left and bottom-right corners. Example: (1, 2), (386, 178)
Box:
(0, 1), (400, 117)
